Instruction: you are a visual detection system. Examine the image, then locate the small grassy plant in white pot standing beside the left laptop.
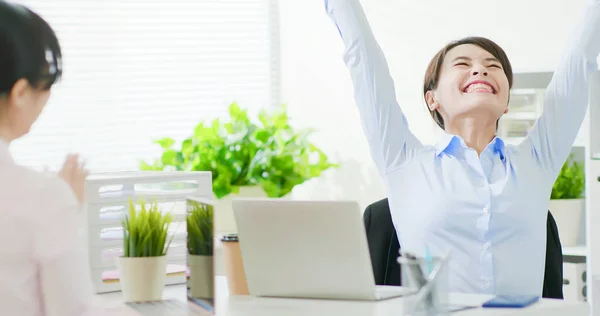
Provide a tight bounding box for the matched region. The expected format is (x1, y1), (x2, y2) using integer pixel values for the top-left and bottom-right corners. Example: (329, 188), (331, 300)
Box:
(117, 199), (173, 302)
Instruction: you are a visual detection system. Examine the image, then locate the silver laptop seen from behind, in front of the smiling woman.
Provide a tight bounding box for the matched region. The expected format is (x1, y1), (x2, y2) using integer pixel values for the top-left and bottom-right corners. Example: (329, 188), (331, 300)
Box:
(232, 198), (415, 301)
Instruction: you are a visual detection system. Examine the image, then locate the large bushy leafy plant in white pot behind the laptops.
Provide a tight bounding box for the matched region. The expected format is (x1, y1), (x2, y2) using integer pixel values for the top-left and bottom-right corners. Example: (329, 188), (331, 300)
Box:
(140, 103), (337, 233)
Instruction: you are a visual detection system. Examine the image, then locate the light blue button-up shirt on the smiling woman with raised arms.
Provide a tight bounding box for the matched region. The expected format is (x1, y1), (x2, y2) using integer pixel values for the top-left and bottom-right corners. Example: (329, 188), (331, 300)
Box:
(325, 0), (600, 295)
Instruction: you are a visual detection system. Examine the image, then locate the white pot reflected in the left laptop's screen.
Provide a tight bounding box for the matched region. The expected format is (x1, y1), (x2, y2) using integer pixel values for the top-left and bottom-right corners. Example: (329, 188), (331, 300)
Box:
(188, 255), (214, 299)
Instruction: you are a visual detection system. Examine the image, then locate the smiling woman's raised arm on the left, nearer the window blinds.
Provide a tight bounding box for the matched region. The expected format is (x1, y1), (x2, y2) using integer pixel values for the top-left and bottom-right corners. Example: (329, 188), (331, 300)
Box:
(325, 0), (422, 174)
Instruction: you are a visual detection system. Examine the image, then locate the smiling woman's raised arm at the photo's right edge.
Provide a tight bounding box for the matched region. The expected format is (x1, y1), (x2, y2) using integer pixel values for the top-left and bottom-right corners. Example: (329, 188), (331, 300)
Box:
(522, 0), (600, 173)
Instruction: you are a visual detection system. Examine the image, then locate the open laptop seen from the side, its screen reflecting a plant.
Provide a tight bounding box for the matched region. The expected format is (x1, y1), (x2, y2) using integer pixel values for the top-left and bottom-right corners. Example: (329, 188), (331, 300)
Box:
(127, 197), (215, 316)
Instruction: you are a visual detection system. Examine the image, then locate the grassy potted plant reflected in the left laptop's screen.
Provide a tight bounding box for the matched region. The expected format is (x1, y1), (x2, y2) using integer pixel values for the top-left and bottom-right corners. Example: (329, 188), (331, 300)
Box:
(186, 199), (214, 299)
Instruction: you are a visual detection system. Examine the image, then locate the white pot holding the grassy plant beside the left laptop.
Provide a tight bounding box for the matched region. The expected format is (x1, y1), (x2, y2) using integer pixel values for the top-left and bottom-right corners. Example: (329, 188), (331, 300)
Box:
(117, 256), (167, 302)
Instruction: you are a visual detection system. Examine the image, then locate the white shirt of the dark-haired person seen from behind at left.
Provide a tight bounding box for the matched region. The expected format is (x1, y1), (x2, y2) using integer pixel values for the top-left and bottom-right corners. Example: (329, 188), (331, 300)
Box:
(0, 139), (134, 316)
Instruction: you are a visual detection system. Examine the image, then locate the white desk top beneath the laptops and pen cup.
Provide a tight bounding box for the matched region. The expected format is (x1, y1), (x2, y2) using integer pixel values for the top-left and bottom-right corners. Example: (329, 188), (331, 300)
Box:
(100, 276), (590, 316)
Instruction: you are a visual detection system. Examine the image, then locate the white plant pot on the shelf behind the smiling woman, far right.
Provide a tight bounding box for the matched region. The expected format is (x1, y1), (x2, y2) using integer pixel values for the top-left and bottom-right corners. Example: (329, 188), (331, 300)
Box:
(549, 199), (585, 247)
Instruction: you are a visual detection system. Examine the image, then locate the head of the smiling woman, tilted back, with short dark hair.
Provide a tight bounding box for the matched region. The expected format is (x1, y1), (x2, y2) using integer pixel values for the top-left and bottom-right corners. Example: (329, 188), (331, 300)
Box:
(424, 38), (512, 128)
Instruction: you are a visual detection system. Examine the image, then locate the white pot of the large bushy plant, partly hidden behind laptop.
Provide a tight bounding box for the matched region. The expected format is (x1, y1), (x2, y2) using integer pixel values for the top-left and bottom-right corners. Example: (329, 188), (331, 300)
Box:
(214, 186), (267, 235)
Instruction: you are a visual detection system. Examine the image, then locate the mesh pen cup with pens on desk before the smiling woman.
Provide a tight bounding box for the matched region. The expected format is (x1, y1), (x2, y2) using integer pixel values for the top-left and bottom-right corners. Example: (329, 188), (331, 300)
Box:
(398, 253), (449, 316)
